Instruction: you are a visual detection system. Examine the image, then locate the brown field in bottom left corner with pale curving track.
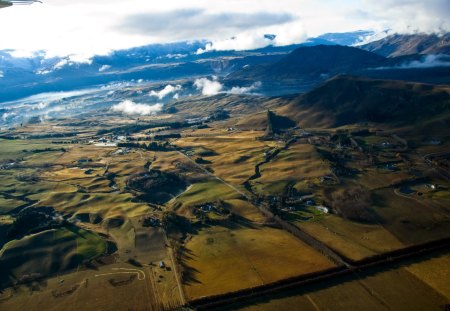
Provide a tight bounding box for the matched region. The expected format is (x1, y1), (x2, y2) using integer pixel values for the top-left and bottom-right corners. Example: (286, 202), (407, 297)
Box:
(0, 264), (181, 311)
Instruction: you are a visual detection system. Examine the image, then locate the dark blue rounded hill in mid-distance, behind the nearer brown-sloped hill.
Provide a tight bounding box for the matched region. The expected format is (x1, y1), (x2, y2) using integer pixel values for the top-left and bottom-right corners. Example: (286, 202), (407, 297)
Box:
(227, 45), (385, 81)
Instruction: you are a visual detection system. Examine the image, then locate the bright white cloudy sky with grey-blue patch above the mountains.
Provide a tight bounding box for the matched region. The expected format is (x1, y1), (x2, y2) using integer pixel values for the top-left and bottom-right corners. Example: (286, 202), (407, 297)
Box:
(0, 0), (450, 62)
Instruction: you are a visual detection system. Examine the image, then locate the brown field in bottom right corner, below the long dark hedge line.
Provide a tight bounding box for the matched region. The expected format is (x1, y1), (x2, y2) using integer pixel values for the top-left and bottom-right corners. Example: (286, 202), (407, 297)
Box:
(229, 255), (449, 311)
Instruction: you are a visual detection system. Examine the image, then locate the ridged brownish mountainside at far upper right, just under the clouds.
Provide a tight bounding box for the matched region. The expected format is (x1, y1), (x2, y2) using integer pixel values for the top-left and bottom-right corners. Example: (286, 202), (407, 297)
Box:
(361, 33), (450, 57)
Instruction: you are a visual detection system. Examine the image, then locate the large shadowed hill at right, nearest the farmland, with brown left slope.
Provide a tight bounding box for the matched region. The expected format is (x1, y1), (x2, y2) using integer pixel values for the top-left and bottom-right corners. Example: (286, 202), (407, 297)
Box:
(279, 76), (450, 127)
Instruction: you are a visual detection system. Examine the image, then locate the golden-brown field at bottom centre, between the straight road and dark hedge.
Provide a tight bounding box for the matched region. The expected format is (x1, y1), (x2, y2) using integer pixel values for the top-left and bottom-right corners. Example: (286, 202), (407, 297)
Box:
(184, 227), (333, 299)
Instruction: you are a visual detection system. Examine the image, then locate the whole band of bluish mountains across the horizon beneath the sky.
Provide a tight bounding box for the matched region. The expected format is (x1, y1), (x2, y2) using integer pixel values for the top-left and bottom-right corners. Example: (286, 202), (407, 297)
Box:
(0, 31), (450, 101)
